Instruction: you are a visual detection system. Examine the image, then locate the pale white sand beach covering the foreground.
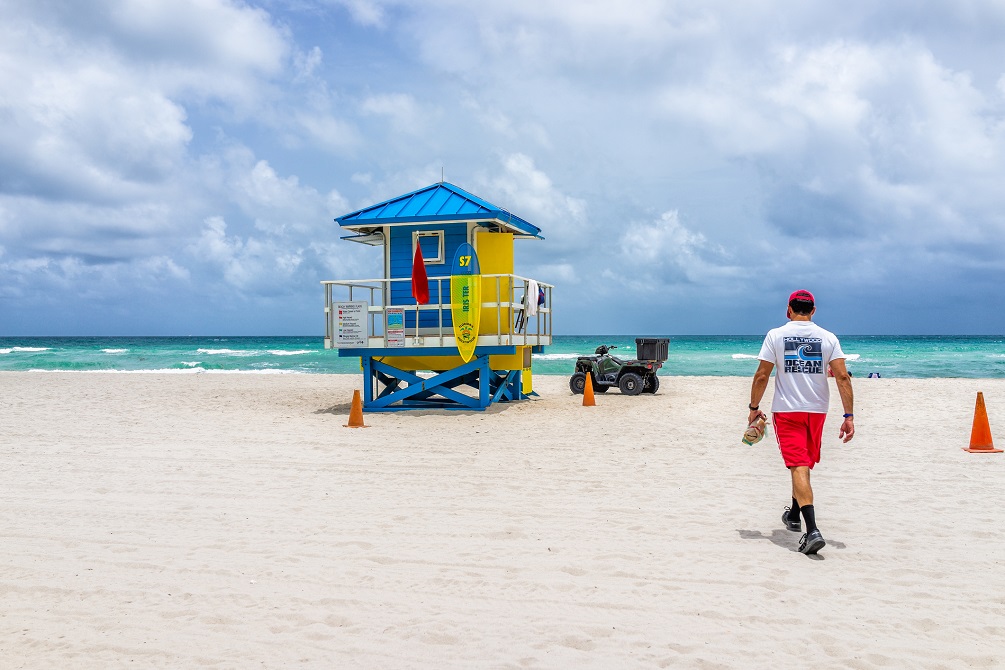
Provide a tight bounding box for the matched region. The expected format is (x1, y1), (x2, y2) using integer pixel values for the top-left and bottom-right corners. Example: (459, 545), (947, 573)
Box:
(0, 373), (1005, 669)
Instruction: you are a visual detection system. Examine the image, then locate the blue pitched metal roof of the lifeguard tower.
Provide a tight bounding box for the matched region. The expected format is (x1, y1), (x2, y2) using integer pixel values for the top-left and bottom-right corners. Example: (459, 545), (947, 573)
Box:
(335, 182), (541, 237)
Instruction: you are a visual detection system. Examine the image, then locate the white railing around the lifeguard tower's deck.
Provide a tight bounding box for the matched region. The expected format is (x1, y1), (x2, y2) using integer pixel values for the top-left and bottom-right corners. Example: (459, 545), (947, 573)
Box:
(321, 274), (555, 349)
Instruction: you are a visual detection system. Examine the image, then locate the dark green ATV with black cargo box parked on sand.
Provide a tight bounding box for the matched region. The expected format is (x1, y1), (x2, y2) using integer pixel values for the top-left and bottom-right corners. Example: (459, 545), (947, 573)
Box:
(569, 338), (670, 396)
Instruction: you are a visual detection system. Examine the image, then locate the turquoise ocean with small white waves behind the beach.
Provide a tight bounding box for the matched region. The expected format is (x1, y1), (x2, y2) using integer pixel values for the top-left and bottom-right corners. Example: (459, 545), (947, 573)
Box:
(0, 336), (1005, 378)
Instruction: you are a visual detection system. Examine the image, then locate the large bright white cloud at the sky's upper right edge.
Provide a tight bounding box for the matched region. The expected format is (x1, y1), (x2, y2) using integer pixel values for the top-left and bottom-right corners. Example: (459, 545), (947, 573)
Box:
(661, 34), (1005, 255)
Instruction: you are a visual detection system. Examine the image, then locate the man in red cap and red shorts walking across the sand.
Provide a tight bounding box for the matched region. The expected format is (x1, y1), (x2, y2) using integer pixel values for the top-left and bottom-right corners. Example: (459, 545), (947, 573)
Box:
(747, 290), (855, 553)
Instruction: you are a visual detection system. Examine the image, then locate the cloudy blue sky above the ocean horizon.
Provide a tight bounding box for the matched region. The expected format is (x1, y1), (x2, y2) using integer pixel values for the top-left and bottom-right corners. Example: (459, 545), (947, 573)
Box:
(0, 0), (1005, 338)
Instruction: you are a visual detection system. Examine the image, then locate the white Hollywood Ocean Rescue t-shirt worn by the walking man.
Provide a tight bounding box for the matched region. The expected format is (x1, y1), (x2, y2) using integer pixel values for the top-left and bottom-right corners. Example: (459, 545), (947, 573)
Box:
(757, 321), (845, 414)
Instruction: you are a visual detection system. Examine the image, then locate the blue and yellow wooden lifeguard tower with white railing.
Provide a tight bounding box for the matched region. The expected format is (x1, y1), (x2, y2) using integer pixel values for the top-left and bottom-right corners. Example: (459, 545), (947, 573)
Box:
(322, 182), (554, 412)
